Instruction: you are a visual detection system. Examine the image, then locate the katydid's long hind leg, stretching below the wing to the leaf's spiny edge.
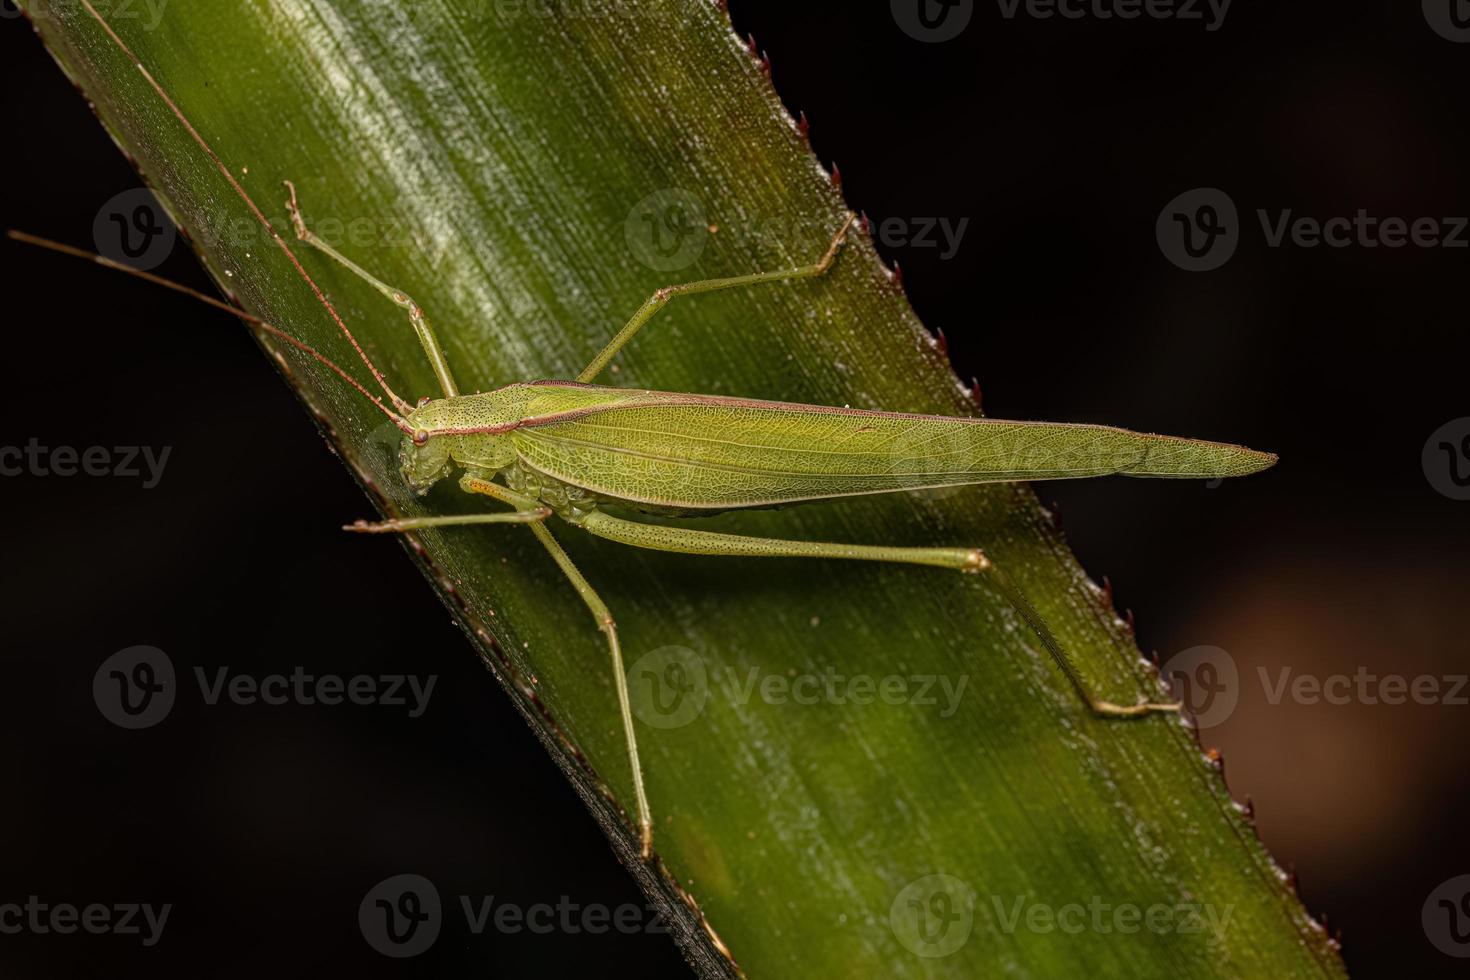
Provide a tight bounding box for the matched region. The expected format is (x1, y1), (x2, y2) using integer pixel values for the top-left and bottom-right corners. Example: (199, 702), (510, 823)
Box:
(575, 511), (1179, 718)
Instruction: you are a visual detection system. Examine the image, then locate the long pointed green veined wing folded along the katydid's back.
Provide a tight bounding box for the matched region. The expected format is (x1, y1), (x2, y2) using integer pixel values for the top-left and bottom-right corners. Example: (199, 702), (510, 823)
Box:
(512, 382), (1276, 511)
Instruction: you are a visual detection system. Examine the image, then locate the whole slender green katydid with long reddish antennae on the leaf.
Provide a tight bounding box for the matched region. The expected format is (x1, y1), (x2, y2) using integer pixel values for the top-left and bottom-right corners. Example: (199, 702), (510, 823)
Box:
(12, 0), (1276, 860)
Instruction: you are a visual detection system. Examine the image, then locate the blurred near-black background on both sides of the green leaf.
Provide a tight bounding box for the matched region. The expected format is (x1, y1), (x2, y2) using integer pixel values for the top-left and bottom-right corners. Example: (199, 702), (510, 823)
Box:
(0, 0), (1470, 977)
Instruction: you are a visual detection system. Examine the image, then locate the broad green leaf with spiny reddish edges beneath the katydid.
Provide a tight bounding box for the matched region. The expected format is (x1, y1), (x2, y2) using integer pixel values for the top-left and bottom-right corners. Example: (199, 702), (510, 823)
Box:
(24, 0), (1342, 979)
